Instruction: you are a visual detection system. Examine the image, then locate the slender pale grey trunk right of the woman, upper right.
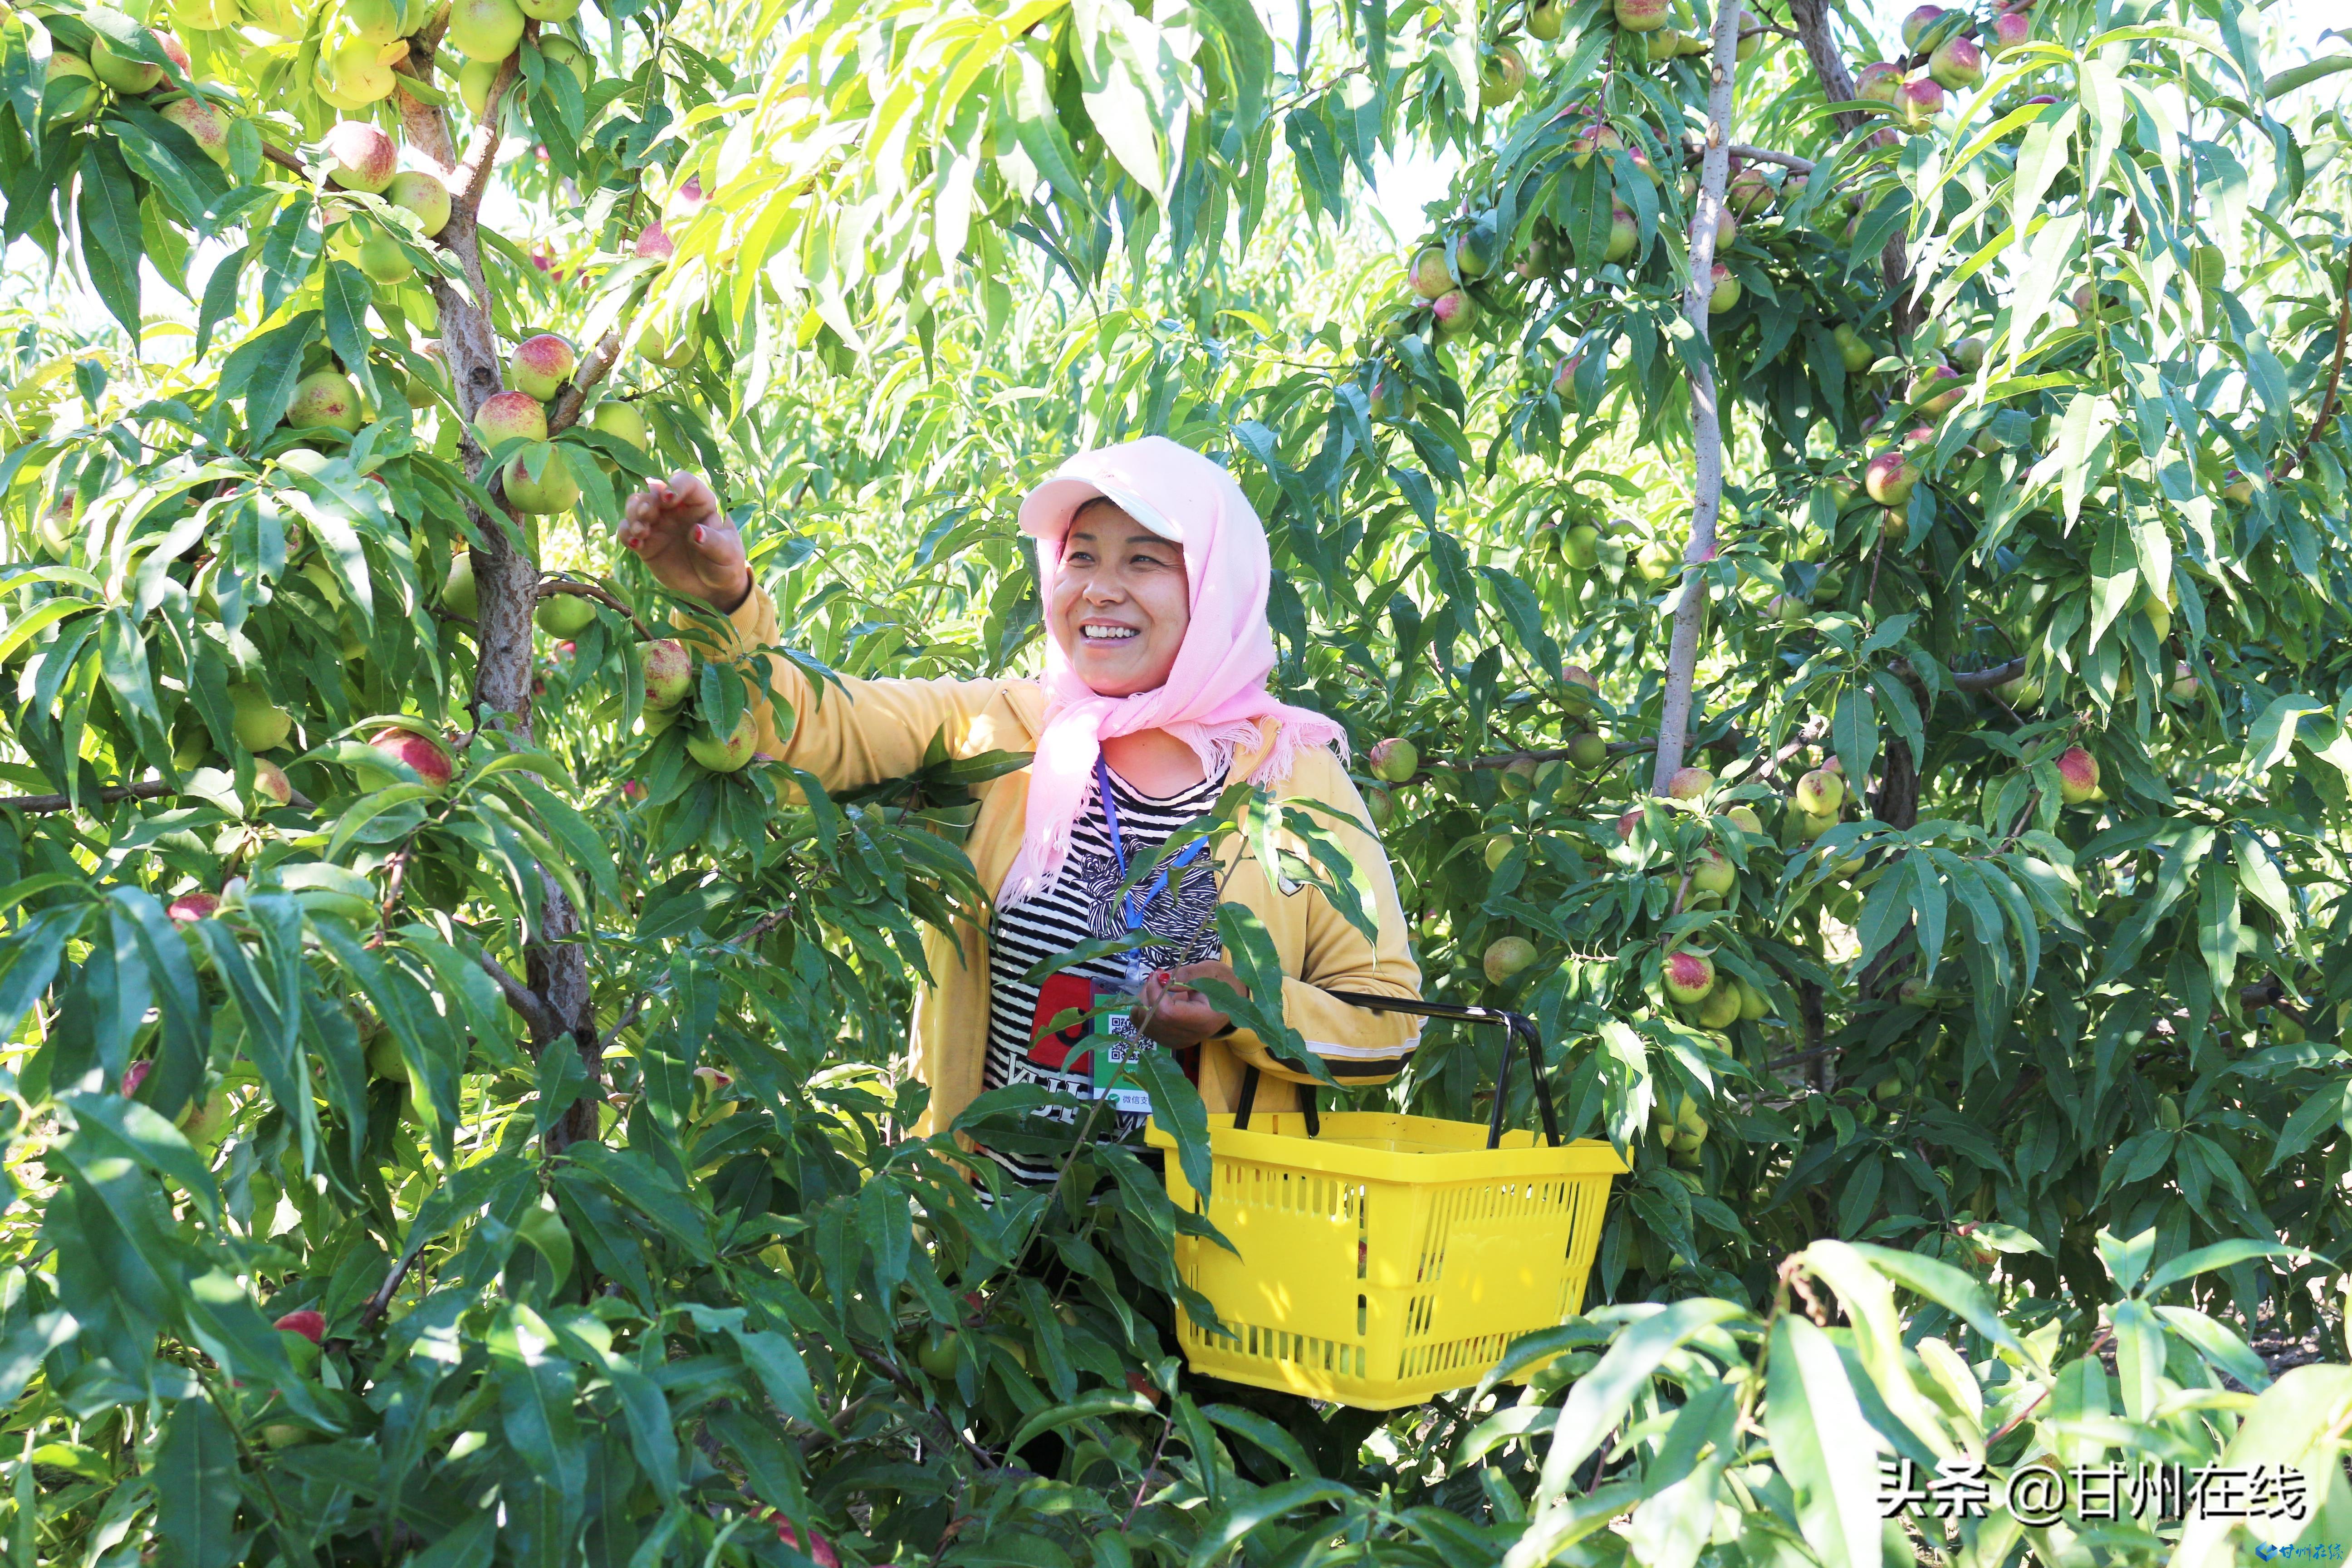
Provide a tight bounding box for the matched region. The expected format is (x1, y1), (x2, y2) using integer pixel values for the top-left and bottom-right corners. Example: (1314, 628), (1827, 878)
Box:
(1651, 0), (1740, 794)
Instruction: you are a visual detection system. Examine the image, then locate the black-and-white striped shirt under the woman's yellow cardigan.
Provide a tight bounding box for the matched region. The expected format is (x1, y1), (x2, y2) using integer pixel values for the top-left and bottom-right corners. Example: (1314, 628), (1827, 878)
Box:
(981, 774), (1225, 1182)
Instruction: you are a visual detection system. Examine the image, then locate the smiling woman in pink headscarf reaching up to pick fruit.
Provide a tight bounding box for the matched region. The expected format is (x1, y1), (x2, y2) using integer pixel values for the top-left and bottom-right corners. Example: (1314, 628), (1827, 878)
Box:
(621, 437), (1421, 1180)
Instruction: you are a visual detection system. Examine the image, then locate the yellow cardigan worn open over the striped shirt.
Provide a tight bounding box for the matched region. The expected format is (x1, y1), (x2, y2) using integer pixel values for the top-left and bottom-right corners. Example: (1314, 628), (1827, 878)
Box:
(710, 590), (1421, 1136)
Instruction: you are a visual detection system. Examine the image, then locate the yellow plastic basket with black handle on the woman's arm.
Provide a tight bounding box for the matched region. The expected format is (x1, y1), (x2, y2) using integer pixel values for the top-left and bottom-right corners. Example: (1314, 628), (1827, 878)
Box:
(1146, 997), (1625, 1411)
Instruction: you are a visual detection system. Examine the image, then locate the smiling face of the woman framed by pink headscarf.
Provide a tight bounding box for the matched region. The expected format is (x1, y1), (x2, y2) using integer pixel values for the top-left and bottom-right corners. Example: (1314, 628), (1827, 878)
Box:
(1047, 501), (1192, 696)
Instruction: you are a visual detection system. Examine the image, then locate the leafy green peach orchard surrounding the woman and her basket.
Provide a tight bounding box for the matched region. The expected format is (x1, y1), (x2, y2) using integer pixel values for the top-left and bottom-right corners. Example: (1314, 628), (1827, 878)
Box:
(0, 0), (2352, 1568)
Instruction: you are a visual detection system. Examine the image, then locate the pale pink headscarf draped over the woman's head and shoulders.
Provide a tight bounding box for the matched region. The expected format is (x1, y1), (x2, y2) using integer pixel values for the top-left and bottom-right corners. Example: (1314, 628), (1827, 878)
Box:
(997, 435), (1348, 907)
